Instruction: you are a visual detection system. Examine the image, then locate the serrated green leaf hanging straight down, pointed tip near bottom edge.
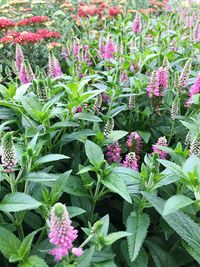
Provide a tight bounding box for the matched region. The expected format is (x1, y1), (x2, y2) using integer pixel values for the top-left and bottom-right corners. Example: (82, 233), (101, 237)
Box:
(126, 212), (150, 261)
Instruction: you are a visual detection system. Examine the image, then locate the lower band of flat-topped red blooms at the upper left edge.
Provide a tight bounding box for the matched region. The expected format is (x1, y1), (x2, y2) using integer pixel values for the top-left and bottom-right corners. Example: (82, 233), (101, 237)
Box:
(0, 29), (61, 44)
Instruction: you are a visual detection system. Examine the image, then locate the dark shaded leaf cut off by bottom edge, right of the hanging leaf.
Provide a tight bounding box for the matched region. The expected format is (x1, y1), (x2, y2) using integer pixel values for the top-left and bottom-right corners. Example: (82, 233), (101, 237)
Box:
(145, 241), (179, 267)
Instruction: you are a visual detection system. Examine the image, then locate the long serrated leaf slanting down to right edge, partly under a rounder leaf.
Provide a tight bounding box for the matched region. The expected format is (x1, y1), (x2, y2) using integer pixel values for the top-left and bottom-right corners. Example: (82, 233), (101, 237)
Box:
(142, 192), (200, 253)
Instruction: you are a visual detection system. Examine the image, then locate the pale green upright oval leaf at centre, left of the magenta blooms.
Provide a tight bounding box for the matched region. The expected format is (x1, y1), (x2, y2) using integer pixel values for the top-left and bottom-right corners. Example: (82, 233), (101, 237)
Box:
(85, 140), (104, 167)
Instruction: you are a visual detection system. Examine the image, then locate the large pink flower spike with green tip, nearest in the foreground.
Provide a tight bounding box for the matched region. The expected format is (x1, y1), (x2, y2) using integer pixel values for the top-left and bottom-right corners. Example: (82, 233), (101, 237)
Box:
(49, 203), (77, 261)
